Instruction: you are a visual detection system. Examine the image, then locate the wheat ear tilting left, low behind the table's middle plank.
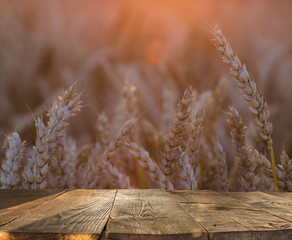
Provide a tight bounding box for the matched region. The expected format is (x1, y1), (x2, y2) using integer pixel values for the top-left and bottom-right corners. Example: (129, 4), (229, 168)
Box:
(127, 142), (174, 190)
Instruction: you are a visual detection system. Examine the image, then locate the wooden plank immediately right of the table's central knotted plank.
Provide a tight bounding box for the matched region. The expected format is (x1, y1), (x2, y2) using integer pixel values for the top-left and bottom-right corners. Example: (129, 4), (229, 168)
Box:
(169, 191), (292, 239)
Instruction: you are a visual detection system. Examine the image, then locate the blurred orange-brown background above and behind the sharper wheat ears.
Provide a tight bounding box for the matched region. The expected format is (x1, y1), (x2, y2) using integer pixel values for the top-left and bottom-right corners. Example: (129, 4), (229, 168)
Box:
(0, 0), (292, 161)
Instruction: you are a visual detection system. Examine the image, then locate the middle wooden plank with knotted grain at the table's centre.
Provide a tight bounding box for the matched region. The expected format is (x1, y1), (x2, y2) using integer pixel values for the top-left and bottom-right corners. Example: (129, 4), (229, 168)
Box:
(103, 189), (207, 240)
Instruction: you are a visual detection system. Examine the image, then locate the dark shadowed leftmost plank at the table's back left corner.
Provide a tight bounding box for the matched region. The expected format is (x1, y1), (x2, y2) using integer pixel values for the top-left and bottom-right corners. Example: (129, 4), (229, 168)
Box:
(0, 189), (66, 226)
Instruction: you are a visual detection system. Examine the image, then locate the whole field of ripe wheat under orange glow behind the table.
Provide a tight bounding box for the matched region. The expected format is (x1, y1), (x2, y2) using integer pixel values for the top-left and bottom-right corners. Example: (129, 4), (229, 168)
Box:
(0, 0), (292, 191)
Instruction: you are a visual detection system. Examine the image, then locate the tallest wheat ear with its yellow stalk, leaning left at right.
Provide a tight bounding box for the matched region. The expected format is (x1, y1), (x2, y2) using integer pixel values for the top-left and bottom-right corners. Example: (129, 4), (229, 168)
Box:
(213, 26), (278, 191)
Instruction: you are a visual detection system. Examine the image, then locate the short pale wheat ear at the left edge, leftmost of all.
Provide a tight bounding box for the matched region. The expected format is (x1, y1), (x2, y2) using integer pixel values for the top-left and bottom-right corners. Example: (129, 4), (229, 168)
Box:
(0, 132), (25, 189)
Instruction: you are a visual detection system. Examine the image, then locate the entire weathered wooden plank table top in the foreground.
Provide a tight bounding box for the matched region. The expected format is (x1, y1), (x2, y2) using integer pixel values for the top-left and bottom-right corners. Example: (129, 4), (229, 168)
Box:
(0, 189), (292, 240)
